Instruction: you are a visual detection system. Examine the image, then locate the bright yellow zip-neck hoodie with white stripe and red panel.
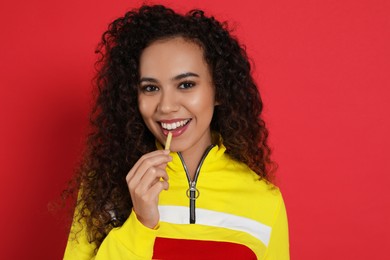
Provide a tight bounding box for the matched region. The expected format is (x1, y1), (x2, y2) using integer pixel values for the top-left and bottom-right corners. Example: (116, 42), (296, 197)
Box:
(64, 144), (289, 260)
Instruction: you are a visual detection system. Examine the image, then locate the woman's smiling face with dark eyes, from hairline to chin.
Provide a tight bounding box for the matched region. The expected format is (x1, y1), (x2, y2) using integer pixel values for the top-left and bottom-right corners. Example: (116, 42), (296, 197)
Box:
(138, 37), (215, 155)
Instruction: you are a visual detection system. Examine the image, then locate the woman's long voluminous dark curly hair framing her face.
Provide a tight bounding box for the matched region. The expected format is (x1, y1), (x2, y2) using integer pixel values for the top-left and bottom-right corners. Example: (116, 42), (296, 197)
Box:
(71, 5), (275, 252)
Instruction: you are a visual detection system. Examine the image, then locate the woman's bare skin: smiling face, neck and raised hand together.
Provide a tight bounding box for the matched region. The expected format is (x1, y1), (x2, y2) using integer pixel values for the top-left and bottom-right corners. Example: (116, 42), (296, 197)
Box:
(126, 37), (216, 228)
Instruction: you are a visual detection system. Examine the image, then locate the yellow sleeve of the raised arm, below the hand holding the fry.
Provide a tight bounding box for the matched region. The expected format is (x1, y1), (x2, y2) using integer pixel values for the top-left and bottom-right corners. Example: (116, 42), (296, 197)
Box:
(64, 211), (158, 260)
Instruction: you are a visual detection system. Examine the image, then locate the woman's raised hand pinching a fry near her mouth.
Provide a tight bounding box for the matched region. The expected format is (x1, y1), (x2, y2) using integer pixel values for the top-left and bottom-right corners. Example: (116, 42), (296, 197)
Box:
(126, 150), (172, 228)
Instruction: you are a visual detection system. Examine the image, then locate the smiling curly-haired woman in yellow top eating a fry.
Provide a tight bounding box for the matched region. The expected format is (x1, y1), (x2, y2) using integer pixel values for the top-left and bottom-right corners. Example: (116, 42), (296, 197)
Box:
(64, 6), (289, 260)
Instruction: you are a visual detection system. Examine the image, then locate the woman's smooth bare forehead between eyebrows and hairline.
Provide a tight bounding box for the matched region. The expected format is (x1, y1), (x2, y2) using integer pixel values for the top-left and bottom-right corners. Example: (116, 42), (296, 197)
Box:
(140, 37), (210, 77)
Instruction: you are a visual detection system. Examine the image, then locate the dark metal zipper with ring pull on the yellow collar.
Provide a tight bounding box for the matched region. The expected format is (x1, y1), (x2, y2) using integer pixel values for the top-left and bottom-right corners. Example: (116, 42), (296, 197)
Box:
(177, 144), (215, 224)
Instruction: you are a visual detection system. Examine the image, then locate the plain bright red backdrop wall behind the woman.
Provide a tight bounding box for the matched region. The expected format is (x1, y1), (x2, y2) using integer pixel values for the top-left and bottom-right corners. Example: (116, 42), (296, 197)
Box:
(0, 0), (390, 260)
